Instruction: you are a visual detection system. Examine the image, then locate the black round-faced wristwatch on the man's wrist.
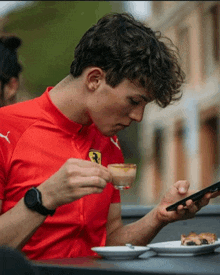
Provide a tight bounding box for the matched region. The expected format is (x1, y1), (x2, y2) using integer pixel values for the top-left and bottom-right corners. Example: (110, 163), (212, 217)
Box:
(24, 187), (56, 216)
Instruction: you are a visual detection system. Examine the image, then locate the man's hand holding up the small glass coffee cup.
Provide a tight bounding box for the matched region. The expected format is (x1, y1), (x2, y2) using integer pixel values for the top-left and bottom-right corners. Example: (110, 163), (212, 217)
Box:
(38, 158), (112, 209)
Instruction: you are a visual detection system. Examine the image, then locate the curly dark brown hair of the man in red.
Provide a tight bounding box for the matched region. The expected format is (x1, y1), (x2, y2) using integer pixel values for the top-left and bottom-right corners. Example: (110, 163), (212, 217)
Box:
(70, 13), (185, 108)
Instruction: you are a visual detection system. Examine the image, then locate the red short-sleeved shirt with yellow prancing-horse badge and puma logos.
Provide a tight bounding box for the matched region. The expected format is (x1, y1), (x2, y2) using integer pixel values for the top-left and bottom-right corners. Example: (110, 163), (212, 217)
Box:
(0, 87), (123, 259)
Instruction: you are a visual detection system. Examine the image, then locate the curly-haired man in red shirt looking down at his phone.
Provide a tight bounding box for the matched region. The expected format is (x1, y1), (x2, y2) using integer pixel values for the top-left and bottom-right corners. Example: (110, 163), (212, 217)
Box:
(0, 14), (218, 259)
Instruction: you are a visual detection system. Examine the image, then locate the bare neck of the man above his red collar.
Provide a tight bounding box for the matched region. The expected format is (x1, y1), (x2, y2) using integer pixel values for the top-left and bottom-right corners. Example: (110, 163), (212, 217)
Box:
(49, 75), (91, 125)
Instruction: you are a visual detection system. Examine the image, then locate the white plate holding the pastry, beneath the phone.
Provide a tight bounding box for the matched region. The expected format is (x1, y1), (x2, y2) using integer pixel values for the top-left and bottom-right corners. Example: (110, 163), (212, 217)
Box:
(147, 239), (220, 256)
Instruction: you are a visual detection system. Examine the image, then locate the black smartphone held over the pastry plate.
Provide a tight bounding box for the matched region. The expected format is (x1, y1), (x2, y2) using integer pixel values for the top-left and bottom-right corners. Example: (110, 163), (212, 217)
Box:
(166, 181), (220, 211)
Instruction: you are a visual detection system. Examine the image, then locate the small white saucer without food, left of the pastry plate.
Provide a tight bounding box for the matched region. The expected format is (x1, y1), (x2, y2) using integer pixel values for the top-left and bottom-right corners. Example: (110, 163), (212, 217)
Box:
(92, 246), (150, 260)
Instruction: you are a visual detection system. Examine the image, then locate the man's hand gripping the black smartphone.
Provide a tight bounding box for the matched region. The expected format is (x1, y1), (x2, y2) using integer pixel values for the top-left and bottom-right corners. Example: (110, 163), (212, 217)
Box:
(156, 180), (215, 223)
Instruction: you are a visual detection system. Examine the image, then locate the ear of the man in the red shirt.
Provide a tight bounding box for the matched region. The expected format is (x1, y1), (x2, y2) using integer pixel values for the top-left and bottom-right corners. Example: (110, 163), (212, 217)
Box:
(86, 67), (105, 91)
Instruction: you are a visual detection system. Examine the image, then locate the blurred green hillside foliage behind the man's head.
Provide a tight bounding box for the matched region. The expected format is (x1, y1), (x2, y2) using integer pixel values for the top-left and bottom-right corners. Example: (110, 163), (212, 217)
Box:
(4, 1), (120, 96)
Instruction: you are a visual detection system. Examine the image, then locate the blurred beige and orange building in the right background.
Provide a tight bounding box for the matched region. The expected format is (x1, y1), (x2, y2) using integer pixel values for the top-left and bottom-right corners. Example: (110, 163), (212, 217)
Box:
(138, 1), (220, 204)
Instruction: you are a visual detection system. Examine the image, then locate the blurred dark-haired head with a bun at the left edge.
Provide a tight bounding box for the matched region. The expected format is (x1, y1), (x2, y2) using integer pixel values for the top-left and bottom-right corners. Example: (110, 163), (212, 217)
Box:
(0, 36), (22, 107)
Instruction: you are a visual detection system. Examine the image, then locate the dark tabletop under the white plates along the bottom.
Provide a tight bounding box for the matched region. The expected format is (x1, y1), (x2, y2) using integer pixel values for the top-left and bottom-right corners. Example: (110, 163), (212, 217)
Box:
(33, 249), (220, 275)
